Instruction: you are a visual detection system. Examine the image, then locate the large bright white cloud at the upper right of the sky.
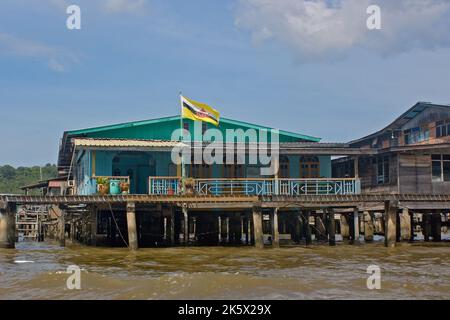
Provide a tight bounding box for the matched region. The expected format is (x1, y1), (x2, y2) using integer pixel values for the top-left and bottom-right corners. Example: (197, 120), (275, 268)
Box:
(236, 0), (450, 59)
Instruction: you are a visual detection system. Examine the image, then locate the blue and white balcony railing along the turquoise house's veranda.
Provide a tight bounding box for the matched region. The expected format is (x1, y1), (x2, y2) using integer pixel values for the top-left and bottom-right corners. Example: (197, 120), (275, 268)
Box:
(149, 177), (361, 196)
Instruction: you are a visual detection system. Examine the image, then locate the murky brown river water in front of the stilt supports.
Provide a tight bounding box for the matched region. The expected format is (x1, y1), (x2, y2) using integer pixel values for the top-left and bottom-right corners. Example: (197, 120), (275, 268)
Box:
(0, 243), (450, 299)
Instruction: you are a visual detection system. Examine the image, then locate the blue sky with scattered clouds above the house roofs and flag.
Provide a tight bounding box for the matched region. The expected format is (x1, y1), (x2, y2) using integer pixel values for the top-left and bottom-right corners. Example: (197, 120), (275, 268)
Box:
(0, 0), (450, 166)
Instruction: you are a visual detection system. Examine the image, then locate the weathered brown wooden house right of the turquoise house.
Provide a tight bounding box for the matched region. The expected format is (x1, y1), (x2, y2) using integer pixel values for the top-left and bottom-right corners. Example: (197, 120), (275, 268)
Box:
(332, 102), (450, 194)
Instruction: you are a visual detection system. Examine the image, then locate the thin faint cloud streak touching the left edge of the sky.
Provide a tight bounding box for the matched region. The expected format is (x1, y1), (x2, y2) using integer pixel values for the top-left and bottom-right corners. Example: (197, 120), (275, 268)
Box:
(0, 32), (79, 72)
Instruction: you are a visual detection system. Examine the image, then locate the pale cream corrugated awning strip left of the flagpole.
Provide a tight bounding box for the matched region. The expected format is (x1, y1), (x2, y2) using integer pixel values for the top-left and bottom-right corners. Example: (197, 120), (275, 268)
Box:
(73, 138), (179, 148)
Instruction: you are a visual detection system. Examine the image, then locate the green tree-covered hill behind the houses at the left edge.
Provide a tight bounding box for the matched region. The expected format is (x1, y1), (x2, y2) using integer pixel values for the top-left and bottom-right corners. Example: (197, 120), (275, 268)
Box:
(0, 163), (58, 194)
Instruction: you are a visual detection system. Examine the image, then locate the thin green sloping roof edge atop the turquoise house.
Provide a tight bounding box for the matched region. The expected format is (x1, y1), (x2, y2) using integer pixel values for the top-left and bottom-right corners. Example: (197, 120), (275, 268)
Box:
(67, 116), (321, 142)
